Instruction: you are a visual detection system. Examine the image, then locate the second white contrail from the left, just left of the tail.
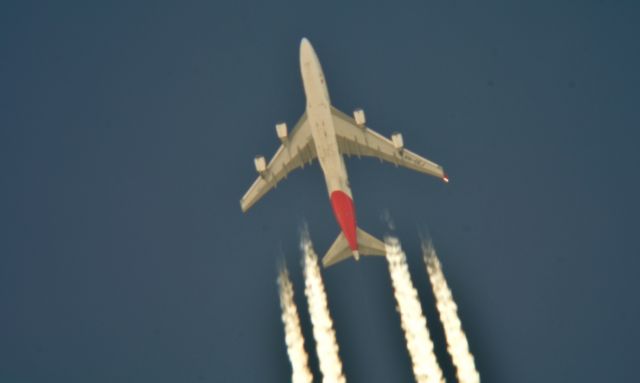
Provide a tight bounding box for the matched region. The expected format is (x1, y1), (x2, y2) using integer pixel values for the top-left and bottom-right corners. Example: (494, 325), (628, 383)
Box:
(301, 235), (346, 383)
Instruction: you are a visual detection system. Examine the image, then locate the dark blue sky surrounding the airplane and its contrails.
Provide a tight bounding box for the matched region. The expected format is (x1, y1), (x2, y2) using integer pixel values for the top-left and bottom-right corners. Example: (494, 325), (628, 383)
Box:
(0, 1), (640, 383)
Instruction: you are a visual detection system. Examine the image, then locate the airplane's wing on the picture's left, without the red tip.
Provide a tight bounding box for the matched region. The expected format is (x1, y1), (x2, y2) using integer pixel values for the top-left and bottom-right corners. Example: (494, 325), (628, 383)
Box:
(240, 113), (316, 212)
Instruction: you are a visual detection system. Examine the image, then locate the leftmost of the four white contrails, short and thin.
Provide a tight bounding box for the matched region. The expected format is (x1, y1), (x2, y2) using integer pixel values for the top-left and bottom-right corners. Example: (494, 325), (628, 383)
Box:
(278, 266), (313, 383)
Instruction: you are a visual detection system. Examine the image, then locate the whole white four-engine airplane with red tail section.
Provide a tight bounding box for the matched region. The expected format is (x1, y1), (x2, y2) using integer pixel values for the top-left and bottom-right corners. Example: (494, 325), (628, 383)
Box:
(240, 38), (449, 268)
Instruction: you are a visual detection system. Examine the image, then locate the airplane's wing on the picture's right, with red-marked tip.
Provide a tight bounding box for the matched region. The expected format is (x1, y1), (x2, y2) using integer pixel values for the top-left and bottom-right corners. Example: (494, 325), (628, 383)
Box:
(331, 107), (448, 182)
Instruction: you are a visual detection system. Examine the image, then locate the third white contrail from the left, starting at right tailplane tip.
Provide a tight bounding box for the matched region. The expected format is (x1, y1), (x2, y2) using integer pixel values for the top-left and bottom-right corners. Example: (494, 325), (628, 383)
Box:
(385, 237), (444, 383)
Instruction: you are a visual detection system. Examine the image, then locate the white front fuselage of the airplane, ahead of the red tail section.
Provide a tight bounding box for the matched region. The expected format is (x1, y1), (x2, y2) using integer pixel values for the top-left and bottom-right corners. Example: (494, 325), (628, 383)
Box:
(300, 39), (352, 198)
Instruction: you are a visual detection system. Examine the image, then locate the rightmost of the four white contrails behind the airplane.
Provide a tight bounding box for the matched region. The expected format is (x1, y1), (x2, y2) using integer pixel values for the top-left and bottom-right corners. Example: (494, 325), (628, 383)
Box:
(422, 243), (480, 383)
